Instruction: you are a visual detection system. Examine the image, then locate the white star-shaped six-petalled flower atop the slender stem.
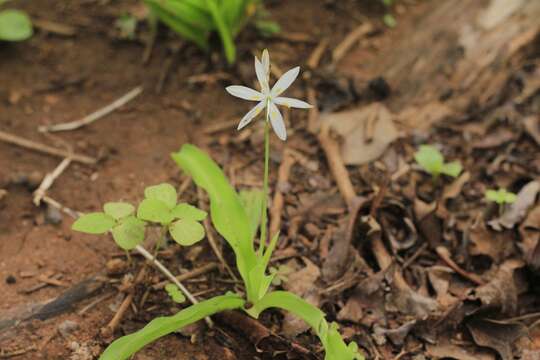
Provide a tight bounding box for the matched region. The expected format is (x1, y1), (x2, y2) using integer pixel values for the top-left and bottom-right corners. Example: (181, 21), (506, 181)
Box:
(226, 50), (312, 141)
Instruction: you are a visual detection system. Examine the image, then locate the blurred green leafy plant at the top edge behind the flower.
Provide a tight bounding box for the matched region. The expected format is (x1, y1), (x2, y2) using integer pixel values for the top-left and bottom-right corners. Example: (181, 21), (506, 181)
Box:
(144, 0), (279, 64)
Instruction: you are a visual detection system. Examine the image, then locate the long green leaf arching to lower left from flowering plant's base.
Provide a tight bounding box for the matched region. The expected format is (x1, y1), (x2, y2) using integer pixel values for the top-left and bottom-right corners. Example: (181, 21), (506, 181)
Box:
(100, 295), (244, 360)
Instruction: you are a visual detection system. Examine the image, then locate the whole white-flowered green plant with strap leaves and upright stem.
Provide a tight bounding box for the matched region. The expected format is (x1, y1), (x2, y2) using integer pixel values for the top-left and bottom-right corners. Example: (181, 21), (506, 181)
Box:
(75, 51), (364, 360)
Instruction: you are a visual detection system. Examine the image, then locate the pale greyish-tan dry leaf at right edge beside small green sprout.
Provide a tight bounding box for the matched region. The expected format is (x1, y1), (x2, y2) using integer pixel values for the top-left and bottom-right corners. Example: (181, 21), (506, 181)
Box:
(489, 180), (540, 231)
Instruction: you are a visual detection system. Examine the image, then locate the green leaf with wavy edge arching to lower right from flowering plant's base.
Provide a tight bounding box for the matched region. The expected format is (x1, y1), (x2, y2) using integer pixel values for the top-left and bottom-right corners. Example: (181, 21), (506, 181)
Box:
(246, 291), (364, 360)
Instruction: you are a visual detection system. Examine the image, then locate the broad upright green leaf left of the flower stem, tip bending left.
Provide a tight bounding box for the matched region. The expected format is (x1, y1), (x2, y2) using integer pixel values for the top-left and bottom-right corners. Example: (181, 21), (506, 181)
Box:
(172, 144), (258, 296)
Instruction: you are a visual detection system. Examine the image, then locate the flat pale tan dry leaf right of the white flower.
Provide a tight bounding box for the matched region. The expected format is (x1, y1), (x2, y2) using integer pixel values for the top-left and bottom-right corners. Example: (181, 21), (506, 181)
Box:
(321, 103), (398, 165)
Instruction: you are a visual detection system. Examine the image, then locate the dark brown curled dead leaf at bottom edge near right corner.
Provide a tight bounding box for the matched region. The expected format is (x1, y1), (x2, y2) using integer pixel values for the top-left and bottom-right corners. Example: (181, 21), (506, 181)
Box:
(467, 319), (527, 360)
